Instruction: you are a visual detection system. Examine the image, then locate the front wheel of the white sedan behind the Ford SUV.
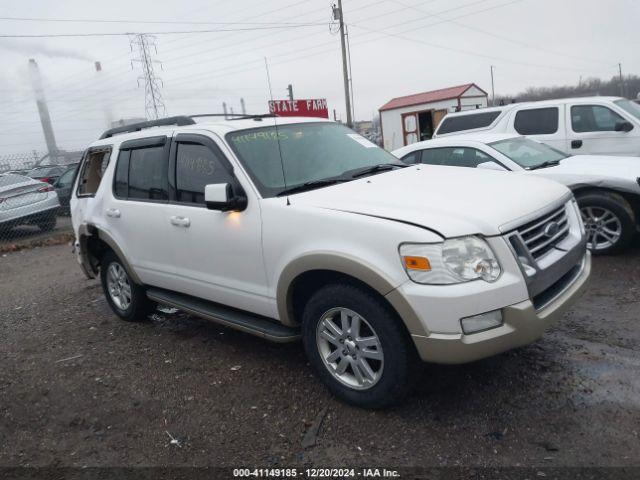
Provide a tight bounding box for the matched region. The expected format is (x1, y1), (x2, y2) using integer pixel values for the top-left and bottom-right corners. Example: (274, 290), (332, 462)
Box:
(577, 192), (636, 255)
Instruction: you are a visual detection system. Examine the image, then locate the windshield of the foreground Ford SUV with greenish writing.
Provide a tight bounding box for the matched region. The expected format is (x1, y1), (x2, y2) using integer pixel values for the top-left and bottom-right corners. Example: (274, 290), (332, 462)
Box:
(226, 122), (405, 197)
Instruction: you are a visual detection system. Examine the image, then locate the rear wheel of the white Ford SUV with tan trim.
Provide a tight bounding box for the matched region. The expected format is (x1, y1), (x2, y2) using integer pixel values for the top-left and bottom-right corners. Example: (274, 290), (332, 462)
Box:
(100, 250), (156, 322)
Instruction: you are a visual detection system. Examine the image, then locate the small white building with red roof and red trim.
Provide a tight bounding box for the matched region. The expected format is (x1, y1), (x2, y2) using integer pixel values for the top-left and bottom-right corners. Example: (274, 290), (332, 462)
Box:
(379, 83), (488, 150)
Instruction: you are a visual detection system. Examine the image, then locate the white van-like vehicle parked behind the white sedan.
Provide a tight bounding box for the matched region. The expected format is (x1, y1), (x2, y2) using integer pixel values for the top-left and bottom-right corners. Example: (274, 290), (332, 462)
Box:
(434, 97), (640, 156)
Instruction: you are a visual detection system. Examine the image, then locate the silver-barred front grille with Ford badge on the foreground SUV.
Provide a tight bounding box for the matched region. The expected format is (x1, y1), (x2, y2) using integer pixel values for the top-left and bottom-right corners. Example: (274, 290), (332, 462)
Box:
(517, 205), (569, 260)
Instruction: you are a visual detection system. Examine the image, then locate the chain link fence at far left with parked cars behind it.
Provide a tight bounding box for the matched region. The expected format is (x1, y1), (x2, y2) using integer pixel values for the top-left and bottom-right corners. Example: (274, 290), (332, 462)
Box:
(0, 150), (82, 253)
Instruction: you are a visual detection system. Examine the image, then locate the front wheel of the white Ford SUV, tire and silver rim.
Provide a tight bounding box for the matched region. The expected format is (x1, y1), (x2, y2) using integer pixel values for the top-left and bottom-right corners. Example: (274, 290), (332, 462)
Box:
(302, 283), (418, 408)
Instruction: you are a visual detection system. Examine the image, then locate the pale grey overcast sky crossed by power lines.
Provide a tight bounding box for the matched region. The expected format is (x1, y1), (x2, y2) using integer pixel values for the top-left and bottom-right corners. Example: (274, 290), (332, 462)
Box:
(0, 0), (640, 156)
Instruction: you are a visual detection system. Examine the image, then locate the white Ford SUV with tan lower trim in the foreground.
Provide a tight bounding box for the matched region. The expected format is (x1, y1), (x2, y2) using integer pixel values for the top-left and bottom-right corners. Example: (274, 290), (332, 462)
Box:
(71, 117), (591, 407)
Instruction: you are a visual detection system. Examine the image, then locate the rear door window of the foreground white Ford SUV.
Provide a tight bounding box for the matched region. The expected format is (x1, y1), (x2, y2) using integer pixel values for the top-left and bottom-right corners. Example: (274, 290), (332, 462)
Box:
(128, 147), (169, 200)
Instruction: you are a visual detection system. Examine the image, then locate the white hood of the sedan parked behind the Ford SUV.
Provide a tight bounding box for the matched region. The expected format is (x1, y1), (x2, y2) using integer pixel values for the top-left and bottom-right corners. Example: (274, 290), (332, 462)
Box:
(530, 155), (640, 194)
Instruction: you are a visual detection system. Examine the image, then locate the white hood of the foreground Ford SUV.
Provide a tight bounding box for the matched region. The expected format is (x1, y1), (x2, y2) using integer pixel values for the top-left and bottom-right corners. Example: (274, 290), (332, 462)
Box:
(290, 165), (569, 237)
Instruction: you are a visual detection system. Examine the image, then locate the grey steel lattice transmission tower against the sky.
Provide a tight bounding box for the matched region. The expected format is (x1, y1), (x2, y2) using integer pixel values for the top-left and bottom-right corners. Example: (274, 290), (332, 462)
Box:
(129, 33), (166, 120)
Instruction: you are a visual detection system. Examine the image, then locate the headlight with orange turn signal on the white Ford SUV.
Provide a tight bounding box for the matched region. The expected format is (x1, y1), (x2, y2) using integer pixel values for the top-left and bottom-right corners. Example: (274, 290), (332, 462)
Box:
(400, 236), (502, 285)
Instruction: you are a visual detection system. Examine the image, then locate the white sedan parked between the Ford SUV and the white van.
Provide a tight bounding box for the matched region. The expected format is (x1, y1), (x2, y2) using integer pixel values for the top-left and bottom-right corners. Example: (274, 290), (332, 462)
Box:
(392, 133), (640, 254)
